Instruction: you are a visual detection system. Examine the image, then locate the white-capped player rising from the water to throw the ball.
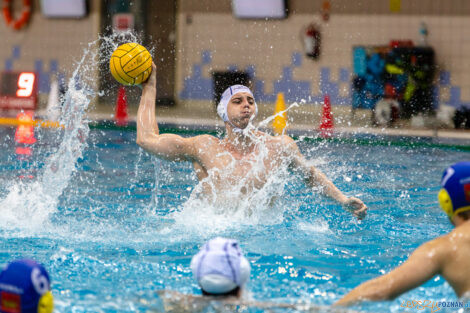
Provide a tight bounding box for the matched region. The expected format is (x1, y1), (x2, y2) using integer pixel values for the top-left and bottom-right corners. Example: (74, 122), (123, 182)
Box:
(137, 64), (367, 218)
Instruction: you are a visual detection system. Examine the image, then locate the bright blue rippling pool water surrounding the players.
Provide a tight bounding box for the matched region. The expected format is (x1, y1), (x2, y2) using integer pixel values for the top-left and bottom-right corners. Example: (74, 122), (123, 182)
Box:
(0, 123), (470, 312)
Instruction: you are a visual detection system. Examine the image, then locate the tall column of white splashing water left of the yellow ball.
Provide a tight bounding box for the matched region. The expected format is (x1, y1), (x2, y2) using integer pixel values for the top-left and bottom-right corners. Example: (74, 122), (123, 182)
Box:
(0, 33), (145, 231)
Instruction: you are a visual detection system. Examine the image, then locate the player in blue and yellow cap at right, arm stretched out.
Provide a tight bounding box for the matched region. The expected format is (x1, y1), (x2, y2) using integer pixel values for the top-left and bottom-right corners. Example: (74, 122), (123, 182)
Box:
(336, 162), (470, 305)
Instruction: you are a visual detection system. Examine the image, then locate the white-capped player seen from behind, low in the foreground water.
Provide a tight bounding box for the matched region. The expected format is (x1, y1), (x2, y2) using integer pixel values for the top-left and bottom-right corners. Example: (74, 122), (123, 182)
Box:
(158, 237), (302, 313)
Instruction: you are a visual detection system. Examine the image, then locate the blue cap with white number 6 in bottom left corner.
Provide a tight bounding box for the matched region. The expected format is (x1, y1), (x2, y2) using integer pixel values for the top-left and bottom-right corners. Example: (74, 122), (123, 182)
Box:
(0, 259), (53, 313)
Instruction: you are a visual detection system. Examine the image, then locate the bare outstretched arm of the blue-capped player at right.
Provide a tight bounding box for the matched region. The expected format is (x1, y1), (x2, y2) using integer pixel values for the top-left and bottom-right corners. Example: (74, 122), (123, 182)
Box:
(334, 238), (446, 306)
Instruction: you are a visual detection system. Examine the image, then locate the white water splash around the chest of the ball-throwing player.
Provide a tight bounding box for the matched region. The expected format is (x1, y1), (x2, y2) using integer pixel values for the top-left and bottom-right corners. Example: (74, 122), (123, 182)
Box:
(170, 103), (324, 235)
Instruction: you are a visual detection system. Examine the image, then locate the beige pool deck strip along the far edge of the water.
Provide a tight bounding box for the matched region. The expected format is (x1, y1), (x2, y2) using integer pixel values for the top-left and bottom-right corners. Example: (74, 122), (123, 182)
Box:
(4, 96), (462, 144)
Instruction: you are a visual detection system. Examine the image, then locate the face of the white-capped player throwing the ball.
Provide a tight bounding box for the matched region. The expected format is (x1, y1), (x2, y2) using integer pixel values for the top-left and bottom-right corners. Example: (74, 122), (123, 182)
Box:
(227, 92), (255, 129)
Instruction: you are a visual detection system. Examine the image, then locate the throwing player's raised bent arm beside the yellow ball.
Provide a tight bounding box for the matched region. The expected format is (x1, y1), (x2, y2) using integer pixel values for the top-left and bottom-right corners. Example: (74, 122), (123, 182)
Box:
(137, 63), (194, 161)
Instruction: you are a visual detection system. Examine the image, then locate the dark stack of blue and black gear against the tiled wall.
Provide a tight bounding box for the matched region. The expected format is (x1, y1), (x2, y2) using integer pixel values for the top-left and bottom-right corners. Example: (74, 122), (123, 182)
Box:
(352, 41), (436, 118)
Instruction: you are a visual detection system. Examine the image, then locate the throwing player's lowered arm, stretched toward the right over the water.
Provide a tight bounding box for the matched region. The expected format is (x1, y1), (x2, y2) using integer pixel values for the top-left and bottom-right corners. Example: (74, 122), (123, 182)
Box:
(282, 136), (367, 219)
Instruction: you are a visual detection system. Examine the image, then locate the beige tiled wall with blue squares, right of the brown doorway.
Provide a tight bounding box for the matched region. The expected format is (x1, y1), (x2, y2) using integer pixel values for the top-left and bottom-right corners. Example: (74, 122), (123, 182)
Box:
(176, 11), (470, 106)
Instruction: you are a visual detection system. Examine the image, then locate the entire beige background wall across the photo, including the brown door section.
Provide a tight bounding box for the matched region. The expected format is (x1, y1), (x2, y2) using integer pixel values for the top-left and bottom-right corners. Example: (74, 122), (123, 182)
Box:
(0, 0), (470, 123)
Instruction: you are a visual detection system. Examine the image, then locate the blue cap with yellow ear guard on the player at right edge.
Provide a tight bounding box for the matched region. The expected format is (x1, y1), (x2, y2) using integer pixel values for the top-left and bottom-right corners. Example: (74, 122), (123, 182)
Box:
(438, 162), (470, 218)
